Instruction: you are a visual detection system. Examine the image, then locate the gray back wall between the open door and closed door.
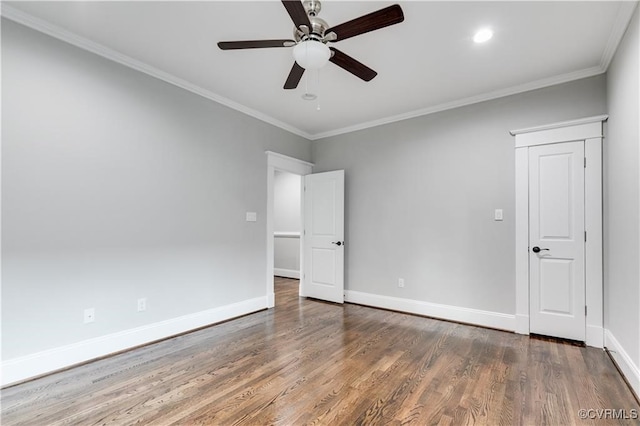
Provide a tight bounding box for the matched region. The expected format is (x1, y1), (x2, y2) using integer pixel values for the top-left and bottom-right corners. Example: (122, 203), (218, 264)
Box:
(313, 75), (607, 314)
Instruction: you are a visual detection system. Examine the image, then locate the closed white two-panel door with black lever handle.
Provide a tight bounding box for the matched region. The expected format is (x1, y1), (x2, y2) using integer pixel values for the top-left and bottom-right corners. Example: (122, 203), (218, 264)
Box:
(529, 141), (586, 341)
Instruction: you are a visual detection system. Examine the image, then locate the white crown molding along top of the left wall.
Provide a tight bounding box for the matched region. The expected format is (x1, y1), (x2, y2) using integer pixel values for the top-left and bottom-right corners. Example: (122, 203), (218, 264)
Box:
(1, 2), (312, 139)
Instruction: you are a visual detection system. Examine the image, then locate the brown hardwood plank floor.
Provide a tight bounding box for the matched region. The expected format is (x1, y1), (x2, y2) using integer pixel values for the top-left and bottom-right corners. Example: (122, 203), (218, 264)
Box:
(1, 278), (640, 425)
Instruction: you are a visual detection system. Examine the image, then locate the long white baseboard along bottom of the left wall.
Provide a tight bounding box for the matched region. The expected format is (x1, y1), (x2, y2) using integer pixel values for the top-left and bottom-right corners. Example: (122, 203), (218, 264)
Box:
(0, 297), (267, 386)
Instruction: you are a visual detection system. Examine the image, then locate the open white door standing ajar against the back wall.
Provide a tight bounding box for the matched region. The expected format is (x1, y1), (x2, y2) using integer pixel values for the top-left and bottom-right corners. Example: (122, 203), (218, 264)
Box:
(300, 170), (344, 303)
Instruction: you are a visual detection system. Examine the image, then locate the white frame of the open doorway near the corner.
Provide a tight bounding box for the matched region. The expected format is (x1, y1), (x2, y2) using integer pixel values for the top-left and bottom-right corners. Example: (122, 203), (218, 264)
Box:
(266, 151), (313, 308)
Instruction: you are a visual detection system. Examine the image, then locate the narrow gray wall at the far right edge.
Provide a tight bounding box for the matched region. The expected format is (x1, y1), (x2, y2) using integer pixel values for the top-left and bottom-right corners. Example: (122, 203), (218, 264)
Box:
(604, 5), (640, 392)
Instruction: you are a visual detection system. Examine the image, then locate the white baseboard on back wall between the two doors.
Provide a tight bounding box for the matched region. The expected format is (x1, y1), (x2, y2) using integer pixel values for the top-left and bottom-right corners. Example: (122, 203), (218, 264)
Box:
(345, 290), (516, 331)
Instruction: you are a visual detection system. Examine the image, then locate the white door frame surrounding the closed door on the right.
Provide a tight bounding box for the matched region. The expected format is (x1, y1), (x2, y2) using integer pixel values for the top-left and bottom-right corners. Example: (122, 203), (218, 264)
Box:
(509, 115), (608, 348)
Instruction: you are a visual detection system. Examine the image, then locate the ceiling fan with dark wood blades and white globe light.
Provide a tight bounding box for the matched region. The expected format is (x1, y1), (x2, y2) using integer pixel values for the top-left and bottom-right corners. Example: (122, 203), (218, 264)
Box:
(218, 0), (404, 89)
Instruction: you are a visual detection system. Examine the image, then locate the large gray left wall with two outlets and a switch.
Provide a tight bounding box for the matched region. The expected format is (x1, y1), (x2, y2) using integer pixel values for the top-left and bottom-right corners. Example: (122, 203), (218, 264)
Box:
(2, 20), (311, 360)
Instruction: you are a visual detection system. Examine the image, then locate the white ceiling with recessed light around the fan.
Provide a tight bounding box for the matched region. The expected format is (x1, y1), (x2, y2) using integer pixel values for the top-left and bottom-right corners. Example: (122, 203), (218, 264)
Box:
(2, 0), (636, 139)
